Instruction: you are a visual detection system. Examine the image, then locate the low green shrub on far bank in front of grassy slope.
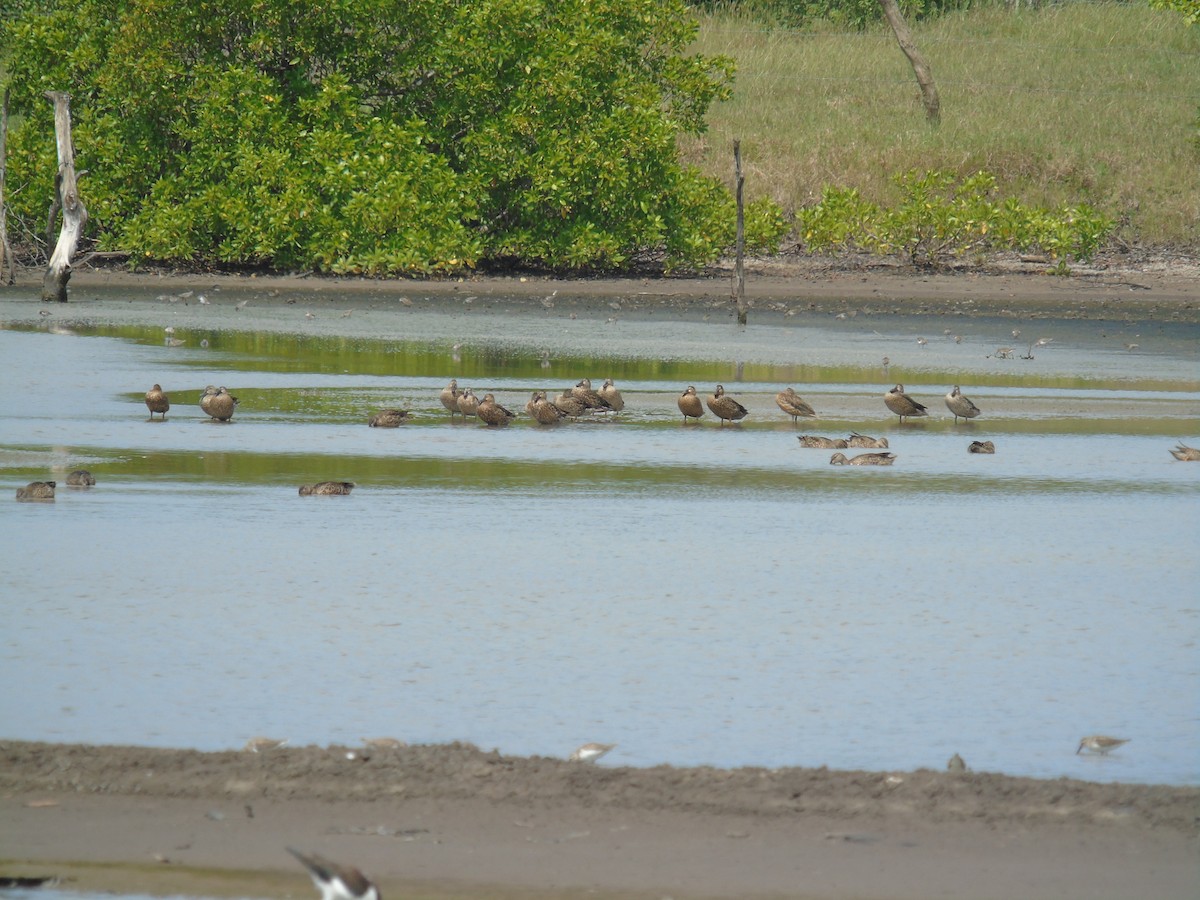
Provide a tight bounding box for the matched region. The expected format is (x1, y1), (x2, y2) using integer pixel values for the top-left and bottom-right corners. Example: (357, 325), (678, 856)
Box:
(797, 172), (1114, 268)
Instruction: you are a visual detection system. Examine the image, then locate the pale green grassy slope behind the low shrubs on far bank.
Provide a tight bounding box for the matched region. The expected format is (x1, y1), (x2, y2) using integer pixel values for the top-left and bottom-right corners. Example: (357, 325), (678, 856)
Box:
(683, 2), (1200, 251)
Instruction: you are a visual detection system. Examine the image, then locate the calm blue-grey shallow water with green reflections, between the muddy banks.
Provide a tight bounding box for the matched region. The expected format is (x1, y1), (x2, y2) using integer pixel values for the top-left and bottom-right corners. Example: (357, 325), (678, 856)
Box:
(0, 292), (1200, 784)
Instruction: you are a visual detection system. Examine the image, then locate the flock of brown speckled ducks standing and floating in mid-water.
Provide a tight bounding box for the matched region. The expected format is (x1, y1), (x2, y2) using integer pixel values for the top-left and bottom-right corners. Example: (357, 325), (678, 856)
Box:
(17, 378), (1200, 500)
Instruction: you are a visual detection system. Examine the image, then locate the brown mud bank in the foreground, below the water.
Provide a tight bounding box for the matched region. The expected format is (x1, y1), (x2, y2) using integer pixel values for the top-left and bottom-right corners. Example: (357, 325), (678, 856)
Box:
(0, 742), (1200, 900)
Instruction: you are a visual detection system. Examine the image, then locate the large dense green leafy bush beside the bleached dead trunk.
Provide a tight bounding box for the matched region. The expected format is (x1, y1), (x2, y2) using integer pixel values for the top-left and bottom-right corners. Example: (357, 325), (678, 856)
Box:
(0, 0), (784, 275)
